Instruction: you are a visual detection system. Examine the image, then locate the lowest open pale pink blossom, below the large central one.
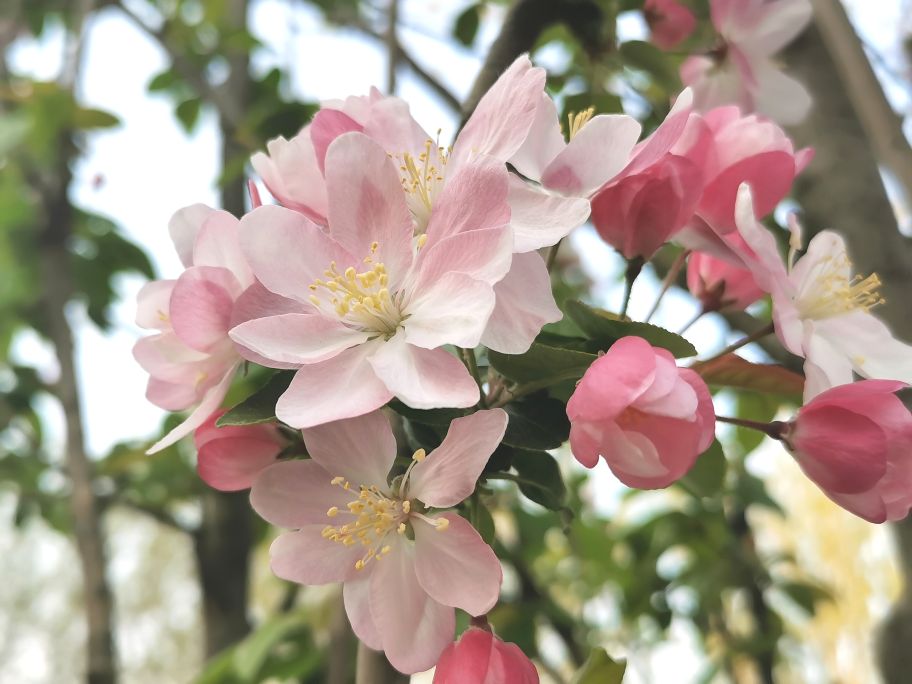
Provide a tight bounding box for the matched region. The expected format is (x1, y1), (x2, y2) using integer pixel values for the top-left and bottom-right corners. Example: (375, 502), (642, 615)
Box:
(250, 409), (507, 673)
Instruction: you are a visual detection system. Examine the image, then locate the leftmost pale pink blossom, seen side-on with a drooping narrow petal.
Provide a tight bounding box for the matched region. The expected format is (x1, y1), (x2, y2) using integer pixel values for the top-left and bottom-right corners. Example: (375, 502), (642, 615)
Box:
(133, 204), (254, 452)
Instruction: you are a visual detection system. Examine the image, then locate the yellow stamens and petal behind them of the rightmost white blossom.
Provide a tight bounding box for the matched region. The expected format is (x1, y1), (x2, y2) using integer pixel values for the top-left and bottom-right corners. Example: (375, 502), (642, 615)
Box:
(795, 254), (885, 320)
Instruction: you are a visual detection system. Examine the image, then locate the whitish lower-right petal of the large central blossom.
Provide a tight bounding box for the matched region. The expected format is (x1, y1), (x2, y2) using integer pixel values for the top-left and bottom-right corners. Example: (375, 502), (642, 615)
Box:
(402, 272), (496, 349)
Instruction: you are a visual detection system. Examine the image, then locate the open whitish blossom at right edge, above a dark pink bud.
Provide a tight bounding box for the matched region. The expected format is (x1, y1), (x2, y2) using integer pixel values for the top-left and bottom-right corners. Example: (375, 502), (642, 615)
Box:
(737, 185), (912, 400)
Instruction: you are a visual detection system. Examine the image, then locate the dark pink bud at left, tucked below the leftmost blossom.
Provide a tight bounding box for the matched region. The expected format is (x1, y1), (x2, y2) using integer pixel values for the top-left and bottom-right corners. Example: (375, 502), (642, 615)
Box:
(193, 411), (286, 492)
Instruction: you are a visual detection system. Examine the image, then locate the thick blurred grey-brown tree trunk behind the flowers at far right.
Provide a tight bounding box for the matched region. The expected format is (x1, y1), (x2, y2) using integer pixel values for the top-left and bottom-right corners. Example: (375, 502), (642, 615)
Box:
(785, 18), (912, 684)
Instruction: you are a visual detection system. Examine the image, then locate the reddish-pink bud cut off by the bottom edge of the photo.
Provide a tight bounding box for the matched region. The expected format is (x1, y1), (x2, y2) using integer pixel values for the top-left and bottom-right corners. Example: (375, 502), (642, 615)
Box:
(433, 627), (539, 684)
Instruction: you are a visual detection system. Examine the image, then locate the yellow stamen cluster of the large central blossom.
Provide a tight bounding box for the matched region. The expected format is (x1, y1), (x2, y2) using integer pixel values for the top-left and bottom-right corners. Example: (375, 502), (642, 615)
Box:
(310, 242), (403, 337)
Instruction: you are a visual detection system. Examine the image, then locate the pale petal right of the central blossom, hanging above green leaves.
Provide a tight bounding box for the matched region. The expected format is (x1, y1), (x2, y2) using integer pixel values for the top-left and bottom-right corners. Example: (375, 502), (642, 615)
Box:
(481, 252), (563, 354)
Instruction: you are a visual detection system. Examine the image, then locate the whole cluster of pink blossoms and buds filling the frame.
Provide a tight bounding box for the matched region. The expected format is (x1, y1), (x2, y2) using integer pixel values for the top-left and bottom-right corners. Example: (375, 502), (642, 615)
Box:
(135, 6), (912, 682)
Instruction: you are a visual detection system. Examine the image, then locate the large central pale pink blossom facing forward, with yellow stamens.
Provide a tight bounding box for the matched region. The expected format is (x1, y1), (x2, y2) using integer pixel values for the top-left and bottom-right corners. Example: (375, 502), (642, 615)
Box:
(231, 133), (512, 427)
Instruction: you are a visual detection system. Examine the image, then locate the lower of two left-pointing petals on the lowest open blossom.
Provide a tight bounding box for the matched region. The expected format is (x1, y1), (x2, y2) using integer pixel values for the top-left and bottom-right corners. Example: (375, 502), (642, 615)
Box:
(269, 523), (364, 585)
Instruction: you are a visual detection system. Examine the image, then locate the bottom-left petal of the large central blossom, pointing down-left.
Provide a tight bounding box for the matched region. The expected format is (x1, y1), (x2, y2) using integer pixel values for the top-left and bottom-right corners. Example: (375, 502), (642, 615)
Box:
(276, 342), (393, 428)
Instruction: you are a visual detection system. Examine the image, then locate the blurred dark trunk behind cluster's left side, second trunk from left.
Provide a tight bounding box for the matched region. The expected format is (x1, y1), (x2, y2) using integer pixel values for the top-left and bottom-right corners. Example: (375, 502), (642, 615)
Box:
(195, 0), (253, 657)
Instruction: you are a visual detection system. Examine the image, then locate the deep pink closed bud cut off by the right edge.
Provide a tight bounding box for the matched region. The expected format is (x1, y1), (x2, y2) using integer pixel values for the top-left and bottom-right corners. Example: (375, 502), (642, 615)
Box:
(782, 380), (912, 523)
